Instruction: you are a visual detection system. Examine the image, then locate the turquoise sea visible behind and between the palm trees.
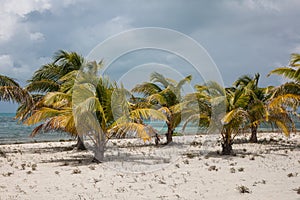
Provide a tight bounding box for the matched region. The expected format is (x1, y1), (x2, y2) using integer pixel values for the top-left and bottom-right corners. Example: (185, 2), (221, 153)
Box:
(0, 113), (300, 144)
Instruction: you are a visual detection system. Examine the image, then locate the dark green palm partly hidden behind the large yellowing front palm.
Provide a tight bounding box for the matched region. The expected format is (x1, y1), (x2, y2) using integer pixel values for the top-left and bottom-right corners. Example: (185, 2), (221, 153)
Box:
(17, 50), (86, 150)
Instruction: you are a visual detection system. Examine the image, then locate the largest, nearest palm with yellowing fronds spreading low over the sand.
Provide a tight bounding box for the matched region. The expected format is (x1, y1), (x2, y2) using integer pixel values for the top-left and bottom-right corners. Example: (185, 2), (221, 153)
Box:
(25, 62), (166, 162)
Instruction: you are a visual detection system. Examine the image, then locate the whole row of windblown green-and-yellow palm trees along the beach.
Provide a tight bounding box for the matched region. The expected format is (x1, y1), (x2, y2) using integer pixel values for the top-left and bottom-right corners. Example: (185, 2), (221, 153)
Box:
(0, 51), (300, 162)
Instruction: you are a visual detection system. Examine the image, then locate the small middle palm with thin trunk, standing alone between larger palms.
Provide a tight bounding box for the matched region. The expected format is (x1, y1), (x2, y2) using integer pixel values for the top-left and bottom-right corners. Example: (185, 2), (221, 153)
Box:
(131, 72), (192, 144)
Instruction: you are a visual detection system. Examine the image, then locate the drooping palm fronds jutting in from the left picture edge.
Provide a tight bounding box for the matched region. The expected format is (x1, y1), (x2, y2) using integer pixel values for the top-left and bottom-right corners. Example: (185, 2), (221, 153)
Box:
(0, 75), (32, 105)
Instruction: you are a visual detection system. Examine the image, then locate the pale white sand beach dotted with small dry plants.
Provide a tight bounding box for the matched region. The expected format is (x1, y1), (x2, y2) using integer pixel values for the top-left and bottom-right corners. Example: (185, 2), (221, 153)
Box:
(0, 134), (300, 200)
